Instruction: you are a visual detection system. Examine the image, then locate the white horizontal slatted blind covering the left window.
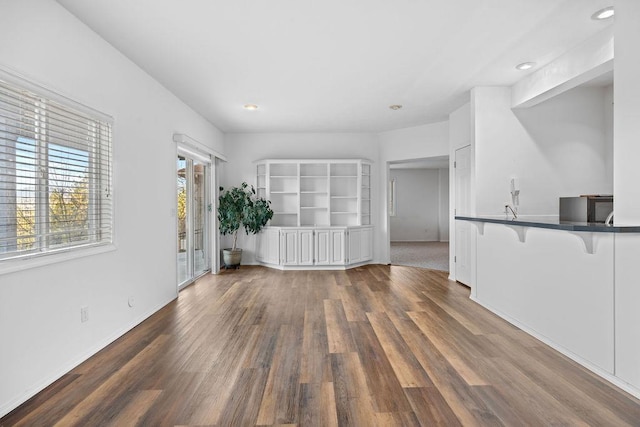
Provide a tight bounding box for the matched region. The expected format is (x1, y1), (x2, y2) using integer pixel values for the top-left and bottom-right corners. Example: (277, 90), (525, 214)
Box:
(0, 76), (113, 260)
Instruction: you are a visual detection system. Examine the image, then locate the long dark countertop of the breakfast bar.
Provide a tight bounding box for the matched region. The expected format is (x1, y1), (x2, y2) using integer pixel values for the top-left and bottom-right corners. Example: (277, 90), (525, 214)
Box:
(455, 216), (640, 233)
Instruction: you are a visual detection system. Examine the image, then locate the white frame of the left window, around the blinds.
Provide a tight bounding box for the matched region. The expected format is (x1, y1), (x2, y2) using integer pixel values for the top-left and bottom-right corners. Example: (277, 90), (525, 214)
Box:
(0, 67), (116, 274)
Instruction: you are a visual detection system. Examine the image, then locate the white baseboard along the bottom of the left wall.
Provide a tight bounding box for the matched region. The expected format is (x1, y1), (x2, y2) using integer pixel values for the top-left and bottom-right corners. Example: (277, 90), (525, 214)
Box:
(0, 295), (177, 417)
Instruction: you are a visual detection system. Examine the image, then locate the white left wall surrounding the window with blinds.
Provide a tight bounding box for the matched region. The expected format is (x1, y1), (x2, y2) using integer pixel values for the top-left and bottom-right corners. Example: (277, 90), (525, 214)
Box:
(0, 0), (224, 415)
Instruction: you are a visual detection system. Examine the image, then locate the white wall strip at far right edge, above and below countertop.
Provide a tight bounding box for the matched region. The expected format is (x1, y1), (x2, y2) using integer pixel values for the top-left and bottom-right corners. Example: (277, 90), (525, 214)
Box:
(614, 0), (640, 396)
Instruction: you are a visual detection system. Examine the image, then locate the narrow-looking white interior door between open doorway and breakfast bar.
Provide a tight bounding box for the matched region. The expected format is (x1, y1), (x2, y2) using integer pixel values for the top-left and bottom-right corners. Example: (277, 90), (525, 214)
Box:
(455, 145), (471, 286)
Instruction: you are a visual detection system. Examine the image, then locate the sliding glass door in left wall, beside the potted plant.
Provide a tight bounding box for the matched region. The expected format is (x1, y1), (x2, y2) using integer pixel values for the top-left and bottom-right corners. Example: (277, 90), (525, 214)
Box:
(176, 154), (211, 287)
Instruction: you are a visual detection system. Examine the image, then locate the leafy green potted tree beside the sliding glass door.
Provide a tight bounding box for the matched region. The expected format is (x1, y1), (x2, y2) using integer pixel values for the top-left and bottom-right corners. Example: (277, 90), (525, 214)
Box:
(218, 182), (273, 268)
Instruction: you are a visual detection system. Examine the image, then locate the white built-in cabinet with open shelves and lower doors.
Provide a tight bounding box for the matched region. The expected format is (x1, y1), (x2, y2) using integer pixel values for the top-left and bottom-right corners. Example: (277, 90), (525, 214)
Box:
(256, 159), (373, 268)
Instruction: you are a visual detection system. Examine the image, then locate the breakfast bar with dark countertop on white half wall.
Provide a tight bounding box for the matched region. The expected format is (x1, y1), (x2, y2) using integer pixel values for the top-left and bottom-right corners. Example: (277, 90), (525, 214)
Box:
(455, 216), (640, 398)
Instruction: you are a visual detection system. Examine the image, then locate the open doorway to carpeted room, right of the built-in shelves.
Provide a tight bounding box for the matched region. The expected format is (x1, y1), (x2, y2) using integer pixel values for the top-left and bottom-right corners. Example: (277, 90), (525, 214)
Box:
(389, 156), (449, 271)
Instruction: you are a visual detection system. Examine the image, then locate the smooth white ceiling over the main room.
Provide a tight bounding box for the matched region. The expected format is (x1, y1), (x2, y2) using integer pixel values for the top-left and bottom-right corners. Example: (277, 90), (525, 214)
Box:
(57, 0), (613, 132)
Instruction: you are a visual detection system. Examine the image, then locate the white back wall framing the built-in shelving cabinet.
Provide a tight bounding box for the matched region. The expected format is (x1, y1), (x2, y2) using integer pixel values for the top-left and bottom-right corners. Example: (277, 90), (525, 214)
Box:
(222, 133), (381, 264)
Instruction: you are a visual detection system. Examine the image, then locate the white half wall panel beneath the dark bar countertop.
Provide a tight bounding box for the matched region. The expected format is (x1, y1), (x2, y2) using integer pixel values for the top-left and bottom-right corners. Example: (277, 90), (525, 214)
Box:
(474, 224), (614, 374)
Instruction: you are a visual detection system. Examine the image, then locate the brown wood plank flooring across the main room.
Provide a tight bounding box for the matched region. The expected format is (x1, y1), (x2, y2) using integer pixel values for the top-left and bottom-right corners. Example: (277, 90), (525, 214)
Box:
(0, 265), (640, 427)
